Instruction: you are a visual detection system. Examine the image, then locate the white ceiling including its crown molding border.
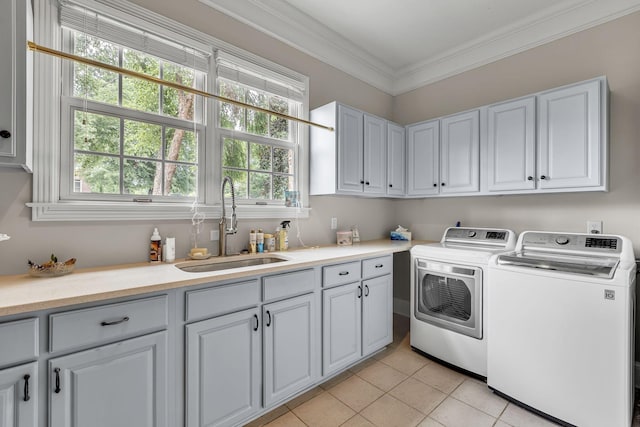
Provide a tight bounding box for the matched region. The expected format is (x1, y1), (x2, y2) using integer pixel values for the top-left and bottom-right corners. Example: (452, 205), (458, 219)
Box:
(200, 0), (640, 95)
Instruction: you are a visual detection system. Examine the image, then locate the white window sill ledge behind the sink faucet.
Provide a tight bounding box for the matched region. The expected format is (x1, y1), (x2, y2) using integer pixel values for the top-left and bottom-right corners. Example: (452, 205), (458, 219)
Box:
(26, 202), (311, 221)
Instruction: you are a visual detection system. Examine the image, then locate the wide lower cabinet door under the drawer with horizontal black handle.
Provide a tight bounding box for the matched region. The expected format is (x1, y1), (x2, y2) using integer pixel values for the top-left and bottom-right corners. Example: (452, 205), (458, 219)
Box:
(48, 332), (168, 427)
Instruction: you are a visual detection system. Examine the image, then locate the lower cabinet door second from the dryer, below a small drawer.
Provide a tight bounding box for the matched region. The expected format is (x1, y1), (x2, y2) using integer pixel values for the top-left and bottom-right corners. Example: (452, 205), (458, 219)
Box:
(322, 282), (362, 376)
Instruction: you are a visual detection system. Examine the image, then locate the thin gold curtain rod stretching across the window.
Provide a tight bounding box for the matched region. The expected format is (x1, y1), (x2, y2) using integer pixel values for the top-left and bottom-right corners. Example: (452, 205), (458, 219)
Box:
(27, 41), (335, 132)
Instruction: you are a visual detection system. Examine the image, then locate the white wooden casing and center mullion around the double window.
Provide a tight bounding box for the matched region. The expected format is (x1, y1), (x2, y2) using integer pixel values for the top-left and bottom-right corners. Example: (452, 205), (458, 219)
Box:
(27, 0), (310, 221)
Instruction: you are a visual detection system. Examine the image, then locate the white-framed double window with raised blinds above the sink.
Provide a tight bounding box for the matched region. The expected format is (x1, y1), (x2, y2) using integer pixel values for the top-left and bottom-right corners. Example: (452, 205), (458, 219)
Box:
(30, 0), (308, 220)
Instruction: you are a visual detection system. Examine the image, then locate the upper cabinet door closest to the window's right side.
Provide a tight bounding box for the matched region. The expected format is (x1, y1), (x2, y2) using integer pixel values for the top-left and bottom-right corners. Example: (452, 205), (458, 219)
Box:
(337, 105), (364, 194)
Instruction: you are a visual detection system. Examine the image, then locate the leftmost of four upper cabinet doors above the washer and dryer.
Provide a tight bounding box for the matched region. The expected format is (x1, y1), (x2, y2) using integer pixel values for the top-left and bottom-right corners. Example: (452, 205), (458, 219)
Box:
(407, 120), (440, 196)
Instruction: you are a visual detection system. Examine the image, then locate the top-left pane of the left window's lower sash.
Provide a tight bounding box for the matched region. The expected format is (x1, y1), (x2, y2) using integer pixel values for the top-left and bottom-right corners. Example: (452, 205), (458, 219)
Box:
(73, 110), (120, 154)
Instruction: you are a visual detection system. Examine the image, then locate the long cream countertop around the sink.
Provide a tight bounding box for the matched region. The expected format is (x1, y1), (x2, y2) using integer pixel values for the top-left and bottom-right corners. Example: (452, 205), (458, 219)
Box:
(0, 240), (425, 316)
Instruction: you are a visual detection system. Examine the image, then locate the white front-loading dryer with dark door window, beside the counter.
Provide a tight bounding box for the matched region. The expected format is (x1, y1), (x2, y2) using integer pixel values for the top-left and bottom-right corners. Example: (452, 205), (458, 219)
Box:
(410, 227), (516, 377)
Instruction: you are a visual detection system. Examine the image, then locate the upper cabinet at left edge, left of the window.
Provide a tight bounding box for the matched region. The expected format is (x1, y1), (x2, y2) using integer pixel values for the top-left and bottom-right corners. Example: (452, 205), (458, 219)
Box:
(0, 0), (33, 172)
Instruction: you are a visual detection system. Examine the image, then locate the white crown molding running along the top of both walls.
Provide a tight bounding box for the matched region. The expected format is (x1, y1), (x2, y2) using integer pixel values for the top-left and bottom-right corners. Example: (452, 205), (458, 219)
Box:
(200, 0), (640, 96)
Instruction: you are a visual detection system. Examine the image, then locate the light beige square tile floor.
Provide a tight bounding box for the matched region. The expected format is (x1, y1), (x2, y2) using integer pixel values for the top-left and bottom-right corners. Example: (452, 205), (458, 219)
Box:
(247, 315), (640, 427)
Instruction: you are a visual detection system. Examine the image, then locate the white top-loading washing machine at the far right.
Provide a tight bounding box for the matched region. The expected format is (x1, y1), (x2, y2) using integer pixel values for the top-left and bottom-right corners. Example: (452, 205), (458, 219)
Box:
(487, 232), (636, 427)
